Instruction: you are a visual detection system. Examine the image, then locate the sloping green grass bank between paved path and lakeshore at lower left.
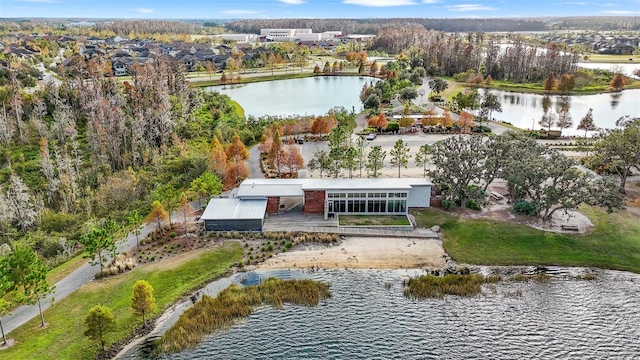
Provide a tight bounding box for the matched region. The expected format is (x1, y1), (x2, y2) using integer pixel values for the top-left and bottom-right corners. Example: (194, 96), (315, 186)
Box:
(2, 242), (243, 359)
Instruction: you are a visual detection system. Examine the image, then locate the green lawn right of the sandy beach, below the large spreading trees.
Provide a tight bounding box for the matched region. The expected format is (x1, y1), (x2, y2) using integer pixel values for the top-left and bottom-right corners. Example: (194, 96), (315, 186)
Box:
(412, 206), (640, 273)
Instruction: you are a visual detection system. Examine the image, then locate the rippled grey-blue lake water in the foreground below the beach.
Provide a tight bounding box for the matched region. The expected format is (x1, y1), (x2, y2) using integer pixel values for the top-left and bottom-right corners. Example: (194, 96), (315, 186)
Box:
(120, 270), (640, 360)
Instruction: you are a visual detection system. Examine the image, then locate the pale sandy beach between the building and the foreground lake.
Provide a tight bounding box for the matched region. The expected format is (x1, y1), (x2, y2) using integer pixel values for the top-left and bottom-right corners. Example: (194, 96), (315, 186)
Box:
(257, 237), (445, 269)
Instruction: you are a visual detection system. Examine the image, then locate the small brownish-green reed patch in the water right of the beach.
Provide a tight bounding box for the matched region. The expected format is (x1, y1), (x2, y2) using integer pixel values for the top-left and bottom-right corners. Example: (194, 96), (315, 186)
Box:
(404, 274), (500, 300)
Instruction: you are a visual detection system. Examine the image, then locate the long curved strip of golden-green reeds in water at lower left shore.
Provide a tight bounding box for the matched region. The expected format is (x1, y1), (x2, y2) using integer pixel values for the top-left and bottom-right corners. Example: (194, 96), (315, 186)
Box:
(160, 278), (331, 352)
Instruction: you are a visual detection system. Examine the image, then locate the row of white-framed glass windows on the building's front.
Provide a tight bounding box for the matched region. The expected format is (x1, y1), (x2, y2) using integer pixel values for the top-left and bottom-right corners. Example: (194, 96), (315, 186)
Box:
(327, 191), (408, 214)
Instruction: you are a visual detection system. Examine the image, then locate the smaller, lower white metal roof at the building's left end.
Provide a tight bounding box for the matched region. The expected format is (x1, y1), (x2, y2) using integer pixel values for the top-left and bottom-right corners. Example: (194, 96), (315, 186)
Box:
(200, 198), (267, 220)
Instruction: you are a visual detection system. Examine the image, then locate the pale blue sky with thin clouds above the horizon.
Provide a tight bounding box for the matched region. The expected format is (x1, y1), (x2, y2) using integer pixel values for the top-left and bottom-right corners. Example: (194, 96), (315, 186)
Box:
(0, 0), (640, 19)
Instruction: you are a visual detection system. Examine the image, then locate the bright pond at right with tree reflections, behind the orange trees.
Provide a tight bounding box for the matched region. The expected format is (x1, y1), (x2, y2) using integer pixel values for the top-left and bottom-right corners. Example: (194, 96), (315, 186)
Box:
(479, 89), (640, 136)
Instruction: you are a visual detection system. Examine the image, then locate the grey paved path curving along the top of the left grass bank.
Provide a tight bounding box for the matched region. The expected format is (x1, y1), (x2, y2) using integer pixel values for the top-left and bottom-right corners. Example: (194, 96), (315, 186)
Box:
(2, 201), (200, 334)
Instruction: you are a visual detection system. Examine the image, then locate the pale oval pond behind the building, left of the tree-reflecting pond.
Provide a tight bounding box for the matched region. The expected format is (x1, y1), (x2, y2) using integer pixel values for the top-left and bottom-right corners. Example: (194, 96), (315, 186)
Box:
(206, 76), (377, 117)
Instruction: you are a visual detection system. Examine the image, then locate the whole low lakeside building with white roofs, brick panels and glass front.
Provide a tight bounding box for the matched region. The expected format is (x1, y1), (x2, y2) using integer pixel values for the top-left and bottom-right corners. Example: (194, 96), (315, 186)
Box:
(200, 178), (432, 231)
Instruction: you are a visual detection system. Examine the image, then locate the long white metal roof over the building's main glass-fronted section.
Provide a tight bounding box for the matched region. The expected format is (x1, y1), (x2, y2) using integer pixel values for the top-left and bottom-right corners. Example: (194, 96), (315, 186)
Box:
(237, 178), (432, 198)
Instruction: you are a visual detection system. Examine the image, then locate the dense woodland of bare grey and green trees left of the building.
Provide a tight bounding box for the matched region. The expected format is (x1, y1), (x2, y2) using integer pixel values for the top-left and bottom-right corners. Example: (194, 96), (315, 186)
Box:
(0, 59), (273, 266)
